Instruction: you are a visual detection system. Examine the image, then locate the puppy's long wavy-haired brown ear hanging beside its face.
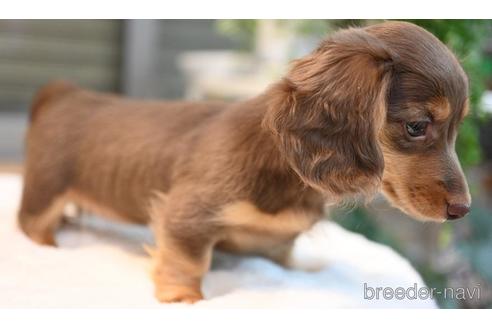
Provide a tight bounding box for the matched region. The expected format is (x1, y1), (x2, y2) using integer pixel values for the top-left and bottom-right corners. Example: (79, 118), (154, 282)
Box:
(263, 29), (395, 197)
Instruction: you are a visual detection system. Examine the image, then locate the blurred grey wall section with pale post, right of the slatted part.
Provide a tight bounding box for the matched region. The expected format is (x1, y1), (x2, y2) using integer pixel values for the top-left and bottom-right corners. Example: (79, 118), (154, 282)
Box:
(123, 20), (238, 99)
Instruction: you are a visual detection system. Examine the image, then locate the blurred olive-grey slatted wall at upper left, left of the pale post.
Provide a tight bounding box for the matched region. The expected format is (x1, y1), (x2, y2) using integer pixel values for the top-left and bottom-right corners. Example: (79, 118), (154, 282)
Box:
(0, 20), (122, 110)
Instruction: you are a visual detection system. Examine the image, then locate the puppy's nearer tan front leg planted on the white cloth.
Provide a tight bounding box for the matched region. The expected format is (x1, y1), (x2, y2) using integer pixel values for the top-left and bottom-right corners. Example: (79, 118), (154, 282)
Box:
(151, 194), (215, 303)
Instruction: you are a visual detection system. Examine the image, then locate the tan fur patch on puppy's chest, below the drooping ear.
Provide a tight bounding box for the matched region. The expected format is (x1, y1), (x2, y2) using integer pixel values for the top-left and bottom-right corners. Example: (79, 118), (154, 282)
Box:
(215, 201), (322, 253)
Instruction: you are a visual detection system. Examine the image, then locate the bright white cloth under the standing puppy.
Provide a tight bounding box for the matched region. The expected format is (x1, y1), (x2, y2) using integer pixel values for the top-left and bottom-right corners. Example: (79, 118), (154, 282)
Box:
(0, 174), (436, 308)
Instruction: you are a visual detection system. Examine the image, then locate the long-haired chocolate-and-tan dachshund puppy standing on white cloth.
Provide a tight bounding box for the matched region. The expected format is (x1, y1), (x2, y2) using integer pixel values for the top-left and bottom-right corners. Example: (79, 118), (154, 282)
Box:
(19, 22), (471, 302)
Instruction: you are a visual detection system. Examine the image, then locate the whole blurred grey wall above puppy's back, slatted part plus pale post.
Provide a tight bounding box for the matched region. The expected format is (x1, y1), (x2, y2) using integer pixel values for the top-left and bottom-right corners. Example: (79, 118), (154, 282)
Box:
(0, 20), (235, 111)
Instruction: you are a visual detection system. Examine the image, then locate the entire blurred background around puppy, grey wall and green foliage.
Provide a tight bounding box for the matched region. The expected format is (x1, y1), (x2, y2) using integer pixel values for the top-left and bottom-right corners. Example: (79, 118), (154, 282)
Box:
(0, 20), (492, 308)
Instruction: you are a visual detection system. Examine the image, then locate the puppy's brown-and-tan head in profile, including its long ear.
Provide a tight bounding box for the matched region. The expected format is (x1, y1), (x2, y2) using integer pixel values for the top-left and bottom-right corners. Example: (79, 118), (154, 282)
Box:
(264, 22), (471, 221)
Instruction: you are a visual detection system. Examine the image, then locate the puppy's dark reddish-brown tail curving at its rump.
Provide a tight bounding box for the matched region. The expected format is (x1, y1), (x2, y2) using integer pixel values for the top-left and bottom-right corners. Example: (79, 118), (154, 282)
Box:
(29, 80), (77, 122)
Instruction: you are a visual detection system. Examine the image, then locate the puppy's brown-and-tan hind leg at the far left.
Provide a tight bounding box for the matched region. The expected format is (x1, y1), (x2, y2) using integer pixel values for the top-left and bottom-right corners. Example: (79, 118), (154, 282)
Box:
(18, 170), (66, 246)
